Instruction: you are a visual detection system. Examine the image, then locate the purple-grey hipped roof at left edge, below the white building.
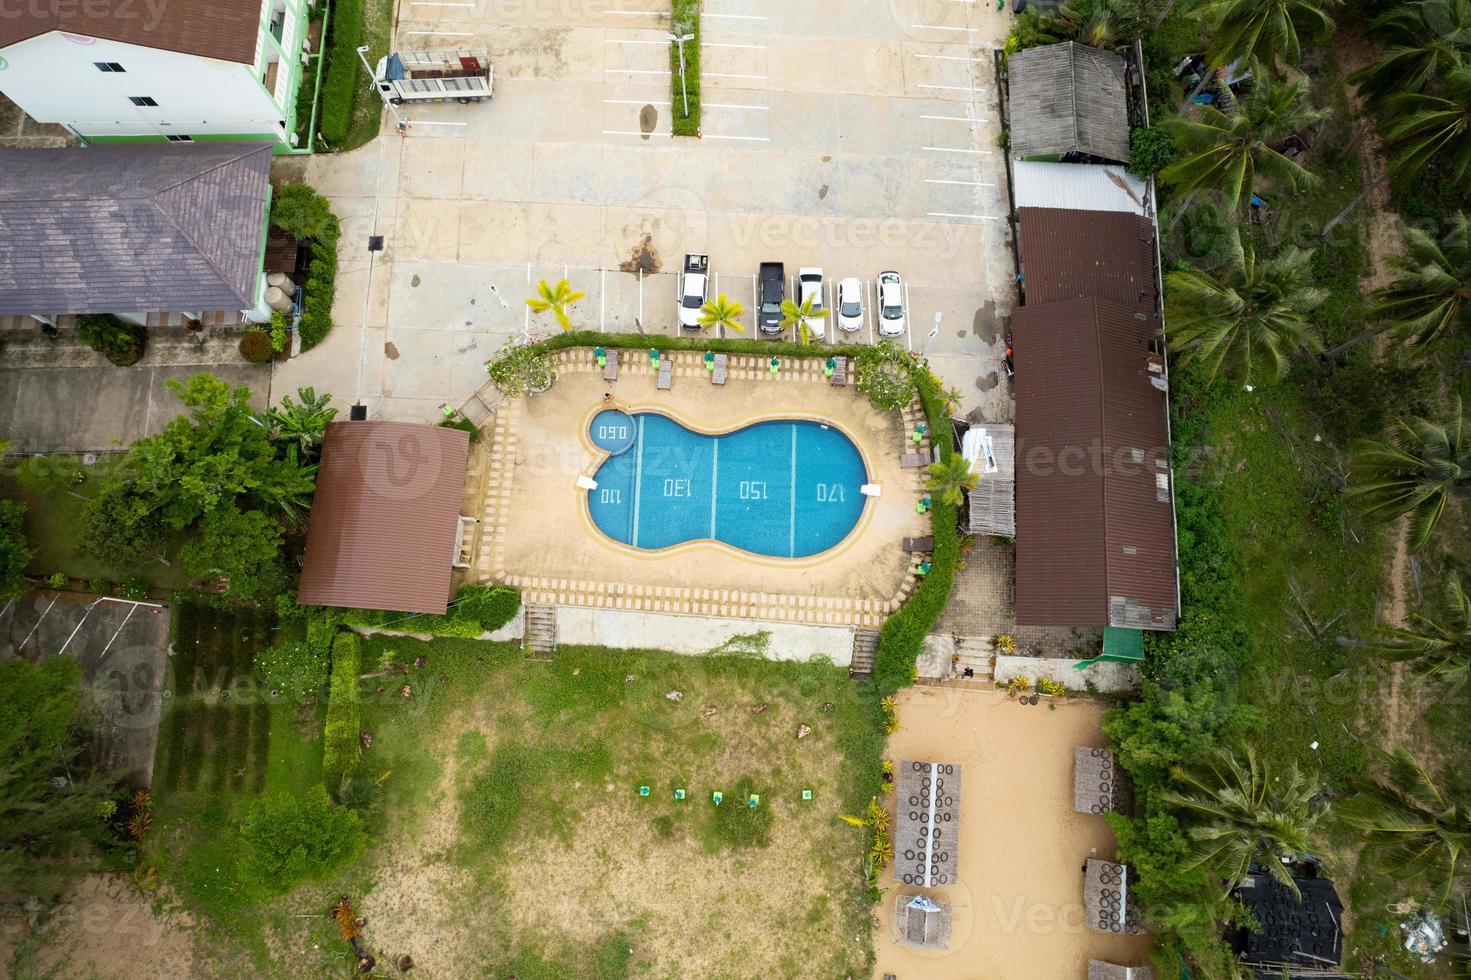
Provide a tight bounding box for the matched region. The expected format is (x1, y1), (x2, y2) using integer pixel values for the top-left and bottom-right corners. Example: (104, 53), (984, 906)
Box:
(0, 143), (271, 313)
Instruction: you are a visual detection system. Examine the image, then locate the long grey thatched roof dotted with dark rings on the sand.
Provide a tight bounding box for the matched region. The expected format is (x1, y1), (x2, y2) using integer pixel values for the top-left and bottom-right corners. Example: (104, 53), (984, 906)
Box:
(893, 759), (961, 889)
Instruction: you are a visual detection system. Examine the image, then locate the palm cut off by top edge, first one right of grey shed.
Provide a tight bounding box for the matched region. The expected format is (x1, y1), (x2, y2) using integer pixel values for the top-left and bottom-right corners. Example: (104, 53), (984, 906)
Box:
(1196, 0), (1342, 69)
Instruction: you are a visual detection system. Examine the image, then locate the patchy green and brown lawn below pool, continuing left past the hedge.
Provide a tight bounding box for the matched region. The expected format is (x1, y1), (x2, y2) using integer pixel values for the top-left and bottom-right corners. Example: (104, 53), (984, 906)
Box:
(150, 620), (884, 980)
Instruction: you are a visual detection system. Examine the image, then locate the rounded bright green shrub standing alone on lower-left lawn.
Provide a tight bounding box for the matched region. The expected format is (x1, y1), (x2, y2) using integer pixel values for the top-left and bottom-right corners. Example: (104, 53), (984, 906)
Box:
(240, 786), (368, 893)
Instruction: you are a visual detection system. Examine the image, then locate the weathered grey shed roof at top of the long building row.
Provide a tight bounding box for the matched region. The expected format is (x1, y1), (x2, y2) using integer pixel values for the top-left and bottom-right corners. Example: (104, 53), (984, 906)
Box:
(1006, 41), (1128, 163)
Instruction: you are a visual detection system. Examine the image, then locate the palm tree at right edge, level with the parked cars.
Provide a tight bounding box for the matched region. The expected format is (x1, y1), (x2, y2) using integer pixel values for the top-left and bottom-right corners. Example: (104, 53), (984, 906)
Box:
(1370, 213), (1471, 347)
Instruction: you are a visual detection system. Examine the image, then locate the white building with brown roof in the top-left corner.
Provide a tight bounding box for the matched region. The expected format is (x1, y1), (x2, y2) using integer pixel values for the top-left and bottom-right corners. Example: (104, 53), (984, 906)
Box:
(0, 0), (310, 150)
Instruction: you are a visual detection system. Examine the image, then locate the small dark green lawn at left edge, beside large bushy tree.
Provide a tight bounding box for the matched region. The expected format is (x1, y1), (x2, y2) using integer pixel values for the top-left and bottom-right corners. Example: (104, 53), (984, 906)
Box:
(0, 455), (188, 589)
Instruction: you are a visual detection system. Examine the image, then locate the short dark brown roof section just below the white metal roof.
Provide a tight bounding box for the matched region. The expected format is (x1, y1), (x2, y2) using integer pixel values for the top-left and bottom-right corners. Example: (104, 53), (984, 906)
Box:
(1016, 207), (1158, 316)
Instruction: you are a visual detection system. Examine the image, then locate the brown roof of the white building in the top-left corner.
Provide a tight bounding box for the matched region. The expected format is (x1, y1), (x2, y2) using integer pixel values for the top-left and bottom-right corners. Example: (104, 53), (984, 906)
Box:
(0, 0), (260, 65)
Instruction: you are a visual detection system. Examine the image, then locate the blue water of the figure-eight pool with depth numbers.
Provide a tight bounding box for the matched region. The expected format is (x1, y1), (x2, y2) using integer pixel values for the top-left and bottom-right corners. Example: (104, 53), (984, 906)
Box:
(588, 409), (868, 558)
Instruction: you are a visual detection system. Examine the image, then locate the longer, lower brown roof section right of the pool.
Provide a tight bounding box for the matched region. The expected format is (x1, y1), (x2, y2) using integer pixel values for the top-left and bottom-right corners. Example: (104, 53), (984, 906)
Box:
(1012, 299), (1178, 630)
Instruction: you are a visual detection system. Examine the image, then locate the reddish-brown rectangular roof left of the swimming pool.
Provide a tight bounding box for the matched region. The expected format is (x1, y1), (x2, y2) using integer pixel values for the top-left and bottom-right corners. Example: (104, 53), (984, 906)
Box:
(297, 421), (469, 614)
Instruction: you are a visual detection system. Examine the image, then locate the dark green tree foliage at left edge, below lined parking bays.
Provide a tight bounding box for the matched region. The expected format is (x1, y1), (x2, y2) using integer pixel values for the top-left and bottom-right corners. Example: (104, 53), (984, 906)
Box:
(0, 656), (110, 896)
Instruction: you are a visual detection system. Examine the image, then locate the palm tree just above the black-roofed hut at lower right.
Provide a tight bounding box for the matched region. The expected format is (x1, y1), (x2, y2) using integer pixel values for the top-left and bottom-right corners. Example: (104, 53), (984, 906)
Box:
(1162, 746), (1327, 895)
